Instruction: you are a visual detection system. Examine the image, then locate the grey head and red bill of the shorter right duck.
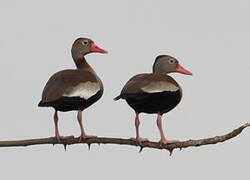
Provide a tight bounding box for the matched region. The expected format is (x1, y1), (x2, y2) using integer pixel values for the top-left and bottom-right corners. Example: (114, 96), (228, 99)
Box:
(153, 55), (192, 75)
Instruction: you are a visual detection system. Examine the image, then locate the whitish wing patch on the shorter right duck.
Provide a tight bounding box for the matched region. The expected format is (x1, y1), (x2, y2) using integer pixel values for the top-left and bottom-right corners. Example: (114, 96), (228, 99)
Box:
(141, 81), (179, 93)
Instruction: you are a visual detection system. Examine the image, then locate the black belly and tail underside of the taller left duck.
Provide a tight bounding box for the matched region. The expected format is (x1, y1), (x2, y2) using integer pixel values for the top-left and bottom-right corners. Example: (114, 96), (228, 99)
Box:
(38, 90), (103, 112)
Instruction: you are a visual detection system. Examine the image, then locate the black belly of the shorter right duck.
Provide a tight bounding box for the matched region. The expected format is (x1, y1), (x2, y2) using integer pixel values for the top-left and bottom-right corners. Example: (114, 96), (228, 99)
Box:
(122, 90), (182, 114)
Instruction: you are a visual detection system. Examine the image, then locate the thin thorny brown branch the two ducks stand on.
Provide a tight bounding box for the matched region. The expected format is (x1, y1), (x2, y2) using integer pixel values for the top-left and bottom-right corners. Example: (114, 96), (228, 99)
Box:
(0, 122), (250, 155)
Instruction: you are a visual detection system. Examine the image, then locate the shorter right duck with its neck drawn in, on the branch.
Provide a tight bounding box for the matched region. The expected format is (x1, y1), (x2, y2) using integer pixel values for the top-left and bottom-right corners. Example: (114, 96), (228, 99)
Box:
(115, 55), (192, 144)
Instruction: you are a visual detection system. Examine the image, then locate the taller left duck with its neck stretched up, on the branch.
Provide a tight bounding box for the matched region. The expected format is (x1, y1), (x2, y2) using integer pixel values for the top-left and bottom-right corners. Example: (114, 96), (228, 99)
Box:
(38, 38), (107, 141)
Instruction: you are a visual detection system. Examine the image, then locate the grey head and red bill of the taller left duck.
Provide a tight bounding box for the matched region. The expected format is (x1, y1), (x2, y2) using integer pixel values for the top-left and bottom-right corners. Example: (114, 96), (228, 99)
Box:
(71, 38), (107, 61)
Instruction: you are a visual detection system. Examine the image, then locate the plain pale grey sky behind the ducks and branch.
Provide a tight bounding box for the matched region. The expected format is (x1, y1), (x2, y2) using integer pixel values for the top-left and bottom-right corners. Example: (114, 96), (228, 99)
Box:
(0, 0), (250, 180)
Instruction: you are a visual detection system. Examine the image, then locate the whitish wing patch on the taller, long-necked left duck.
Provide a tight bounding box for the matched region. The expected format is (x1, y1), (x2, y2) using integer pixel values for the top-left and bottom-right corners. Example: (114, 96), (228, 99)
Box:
(63, 81), (100, 100)
